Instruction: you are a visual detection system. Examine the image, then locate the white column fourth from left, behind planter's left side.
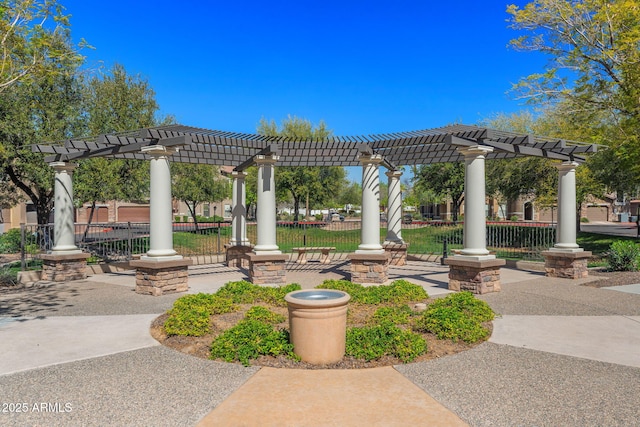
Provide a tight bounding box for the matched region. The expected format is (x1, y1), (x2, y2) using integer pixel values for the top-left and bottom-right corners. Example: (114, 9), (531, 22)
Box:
(253, 155), (282, 255)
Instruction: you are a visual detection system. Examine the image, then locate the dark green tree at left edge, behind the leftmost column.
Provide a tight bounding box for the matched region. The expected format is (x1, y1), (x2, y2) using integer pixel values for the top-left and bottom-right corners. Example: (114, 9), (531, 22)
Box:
(0, 33), (82, 224)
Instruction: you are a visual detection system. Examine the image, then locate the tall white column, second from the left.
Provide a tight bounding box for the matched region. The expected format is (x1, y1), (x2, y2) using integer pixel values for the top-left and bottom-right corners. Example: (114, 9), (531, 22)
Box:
(140, 145), (182, 261)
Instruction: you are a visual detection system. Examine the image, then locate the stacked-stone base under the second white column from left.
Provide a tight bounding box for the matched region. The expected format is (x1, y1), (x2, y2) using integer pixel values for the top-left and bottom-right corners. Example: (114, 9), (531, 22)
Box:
(129, 259), (193, 296)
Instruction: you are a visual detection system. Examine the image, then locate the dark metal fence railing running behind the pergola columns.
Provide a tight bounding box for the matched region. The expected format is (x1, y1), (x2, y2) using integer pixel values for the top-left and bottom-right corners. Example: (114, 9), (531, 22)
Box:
(21, 220), (555, 269)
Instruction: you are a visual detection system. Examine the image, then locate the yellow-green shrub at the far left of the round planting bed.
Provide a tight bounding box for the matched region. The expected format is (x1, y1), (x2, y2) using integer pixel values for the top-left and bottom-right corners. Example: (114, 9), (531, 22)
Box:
(164, 293), (237, 337)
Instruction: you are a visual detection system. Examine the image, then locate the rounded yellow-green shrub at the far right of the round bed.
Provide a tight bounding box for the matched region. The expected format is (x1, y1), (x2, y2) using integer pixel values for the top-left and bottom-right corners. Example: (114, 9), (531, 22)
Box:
(415, 292), (495, 343)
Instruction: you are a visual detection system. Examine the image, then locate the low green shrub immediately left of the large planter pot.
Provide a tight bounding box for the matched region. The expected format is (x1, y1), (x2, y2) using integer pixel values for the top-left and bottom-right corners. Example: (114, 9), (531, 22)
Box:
(211, 319), (297, 366)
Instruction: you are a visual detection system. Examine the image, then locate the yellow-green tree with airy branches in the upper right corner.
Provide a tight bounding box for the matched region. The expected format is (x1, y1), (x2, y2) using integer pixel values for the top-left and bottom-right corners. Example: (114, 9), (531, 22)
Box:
(507, 0), (640, 176)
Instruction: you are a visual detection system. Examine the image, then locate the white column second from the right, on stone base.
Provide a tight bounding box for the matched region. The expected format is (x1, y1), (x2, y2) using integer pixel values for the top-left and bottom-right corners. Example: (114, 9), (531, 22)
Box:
(458, 146), (495, 259)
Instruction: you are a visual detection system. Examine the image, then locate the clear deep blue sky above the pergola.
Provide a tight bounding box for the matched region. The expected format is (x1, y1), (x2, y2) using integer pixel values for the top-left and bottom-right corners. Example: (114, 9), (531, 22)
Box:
(60, 0), (544, 181)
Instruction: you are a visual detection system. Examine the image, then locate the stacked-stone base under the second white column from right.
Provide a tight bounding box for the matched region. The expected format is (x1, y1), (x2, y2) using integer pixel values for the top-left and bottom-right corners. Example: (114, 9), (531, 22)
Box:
(445, 256), (507, 294)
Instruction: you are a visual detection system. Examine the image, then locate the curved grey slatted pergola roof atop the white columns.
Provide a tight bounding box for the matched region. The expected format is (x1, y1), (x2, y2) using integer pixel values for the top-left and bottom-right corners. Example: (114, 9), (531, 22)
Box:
(32, 125), (597, 171)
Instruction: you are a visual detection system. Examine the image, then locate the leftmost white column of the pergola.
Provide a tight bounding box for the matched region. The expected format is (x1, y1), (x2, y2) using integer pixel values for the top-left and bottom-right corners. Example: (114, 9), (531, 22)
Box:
(49, 162), (80, 255)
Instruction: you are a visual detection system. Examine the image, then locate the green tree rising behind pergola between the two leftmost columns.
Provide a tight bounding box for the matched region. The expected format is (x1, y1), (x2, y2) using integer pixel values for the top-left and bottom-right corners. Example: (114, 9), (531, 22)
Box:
(74, 64), (159, 227)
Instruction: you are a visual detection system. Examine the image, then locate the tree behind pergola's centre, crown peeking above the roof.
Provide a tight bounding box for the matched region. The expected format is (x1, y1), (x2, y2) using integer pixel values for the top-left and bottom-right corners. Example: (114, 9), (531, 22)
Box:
(258, 116), (345, 221)
